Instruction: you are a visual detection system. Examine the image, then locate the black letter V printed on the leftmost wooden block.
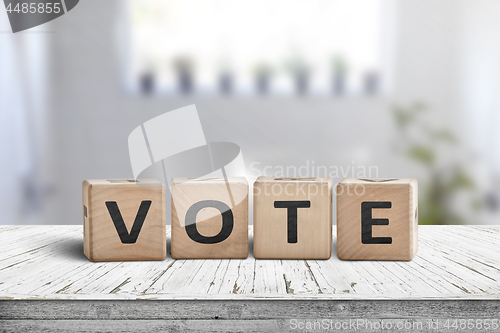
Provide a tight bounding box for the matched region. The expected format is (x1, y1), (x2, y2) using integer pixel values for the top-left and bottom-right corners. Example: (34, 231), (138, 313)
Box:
(106, 200), (151, 244)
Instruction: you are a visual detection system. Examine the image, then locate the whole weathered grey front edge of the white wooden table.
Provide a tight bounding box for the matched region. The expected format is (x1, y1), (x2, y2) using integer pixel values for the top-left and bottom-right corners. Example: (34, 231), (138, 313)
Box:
(0, 299), (500, 332)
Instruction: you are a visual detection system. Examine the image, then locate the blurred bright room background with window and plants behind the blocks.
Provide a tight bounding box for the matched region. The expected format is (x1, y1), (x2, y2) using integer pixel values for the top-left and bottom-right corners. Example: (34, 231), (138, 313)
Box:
(0, 0), (500, 224)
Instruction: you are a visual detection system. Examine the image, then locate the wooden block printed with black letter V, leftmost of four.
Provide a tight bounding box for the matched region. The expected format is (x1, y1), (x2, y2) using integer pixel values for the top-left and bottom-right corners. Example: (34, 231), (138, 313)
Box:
(82, 179), (167, 261)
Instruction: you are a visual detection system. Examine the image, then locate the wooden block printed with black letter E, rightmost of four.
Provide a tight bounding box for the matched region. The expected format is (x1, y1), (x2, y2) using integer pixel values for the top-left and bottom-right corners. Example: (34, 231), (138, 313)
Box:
(337, 178), (418, 260)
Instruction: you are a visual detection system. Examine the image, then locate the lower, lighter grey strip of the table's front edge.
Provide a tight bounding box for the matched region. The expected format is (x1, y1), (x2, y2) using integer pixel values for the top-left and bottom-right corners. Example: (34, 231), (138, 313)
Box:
(0, 314), (496, 333)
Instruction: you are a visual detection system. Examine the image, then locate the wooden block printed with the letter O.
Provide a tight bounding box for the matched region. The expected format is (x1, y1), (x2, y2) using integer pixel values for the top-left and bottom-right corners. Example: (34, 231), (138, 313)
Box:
(170, 177), (248, 259)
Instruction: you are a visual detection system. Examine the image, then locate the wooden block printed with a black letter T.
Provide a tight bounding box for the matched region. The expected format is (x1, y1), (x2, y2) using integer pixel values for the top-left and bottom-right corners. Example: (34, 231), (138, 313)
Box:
(253, 177), (333, 259)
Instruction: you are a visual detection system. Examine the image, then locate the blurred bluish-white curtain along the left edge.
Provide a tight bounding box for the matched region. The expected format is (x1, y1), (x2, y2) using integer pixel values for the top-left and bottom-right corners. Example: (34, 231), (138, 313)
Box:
(0, 10), (50, 224)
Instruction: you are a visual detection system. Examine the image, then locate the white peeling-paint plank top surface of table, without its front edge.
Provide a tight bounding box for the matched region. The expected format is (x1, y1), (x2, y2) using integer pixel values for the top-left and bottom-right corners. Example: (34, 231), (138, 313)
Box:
(0, 225), (500, 300)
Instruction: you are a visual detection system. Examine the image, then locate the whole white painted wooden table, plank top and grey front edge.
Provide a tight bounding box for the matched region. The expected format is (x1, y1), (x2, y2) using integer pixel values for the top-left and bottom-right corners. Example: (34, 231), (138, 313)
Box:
(0, 226), (500, 331)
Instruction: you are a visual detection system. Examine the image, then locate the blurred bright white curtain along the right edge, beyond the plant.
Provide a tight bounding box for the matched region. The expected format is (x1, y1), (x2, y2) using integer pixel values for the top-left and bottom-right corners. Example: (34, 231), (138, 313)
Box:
(458, 0), (500, 224)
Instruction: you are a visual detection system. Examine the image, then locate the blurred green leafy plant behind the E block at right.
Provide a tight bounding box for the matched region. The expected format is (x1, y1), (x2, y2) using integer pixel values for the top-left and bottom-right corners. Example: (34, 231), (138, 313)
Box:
(393, 103), (481, 224)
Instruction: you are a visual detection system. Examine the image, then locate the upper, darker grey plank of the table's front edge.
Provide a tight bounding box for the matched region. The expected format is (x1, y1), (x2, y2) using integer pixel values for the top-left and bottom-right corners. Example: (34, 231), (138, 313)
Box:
(0, 299), (500, 320)
